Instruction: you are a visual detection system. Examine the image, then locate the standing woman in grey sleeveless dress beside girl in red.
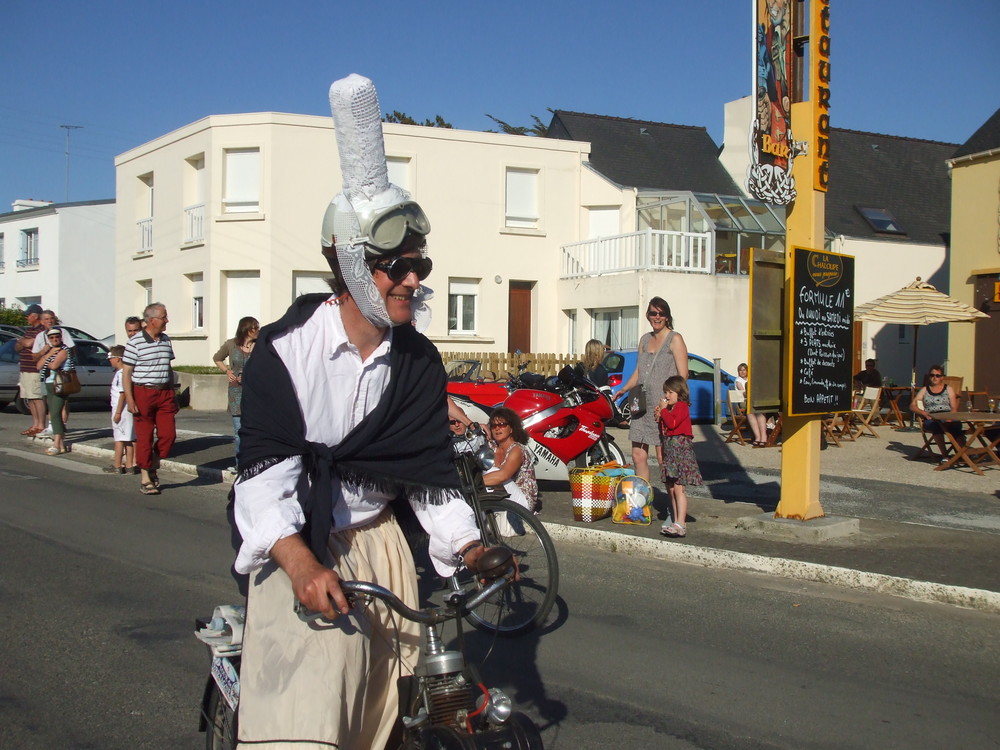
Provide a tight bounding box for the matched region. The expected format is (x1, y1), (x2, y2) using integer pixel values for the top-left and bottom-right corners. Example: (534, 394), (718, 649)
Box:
(624, 297), (688, 481)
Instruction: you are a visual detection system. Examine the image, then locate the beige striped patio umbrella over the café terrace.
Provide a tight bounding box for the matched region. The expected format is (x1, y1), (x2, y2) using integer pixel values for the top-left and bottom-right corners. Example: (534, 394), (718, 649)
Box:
(854, 276), (990, 386)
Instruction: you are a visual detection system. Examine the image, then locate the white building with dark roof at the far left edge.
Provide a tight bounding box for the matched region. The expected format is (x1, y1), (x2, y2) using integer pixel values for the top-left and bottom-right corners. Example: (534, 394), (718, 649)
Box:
(0, 200), (115, 338)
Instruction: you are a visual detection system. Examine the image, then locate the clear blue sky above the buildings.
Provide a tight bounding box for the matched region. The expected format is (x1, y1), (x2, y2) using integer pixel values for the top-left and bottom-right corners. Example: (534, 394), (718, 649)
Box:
(0, 0), (1000, 212)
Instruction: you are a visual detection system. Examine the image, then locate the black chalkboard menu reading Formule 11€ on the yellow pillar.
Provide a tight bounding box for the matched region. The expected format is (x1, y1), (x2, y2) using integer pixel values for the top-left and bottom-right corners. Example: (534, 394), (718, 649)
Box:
(786, 247), (854, 416)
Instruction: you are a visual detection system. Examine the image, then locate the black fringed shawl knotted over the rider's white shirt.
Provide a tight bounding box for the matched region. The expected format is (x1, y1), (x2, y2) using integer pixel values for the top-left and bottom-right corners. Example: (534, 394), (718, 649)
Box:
(239, 294), (459, 560)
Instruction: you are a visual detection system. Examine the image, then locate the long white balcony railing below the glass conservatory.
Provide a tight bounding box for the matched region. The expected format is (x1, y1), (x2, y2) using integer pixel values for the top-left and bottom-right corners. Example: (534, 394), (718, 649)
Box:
(560, 229), (714, 279)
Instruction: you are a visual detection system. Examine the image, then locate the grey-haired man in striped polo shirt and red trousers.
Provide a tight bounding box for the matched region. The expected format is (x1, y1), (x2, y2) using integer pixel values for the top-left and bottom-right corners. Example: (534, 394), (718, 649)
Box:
(122, 302), (177, 495)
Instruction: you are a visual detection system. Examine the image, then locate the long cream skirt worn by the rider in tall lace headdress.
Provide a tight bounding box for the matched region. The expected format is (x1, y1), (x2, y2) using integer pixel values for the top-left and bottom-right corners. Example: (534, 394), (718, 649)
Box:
(237, 509), (420, 750)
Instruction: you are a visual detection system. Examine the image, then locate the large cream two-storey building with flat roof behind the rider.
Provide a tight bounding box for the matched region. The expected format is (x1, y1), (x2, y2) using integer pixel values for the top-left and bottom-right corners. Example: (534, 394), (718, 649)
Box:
(115, 113), (612, 364)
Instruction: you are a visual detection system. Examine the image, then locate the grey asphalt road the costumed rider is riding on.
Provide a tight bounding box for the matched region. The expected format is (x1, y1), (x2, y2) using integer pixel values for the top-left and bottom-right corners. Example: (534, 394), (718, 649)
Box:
(0, 450), (1000, 750)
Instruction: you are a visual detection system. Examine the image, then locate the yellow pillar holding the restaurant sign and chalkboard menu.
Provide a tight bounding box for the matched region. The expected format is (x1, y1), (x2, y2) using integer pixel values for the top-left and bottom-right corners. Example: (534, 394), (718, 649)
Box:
(774, 101), (826, 521)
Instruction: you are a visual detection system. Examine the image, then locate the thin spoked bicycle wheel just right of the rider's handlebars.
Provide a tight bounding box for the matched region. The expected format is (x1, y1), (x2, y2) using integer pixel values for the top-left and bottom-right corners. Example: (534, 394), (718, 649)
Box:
(466, 500), (559, 636)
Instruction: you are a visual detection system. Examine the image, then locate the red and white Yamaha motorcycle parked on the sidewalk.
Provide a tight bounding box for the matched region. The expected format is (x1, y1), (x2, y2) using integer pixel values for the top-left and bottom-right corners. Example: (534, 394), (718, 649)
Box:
(448, 363), (626, 481)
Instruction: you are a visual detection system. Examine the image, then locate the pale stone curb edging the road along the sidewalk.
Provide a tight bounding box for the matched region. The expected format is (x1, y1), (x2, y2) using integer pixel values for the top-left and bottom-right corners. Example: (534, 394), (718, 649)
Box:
(52, 443), (1000, 614)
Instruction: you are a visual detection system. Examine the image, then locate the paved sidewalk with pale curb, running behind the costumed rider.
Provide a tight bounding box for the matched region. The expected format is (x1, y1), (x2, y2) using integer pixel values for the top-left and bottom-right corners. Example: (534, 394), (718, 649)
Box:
(0, 409), (1000, 613)
